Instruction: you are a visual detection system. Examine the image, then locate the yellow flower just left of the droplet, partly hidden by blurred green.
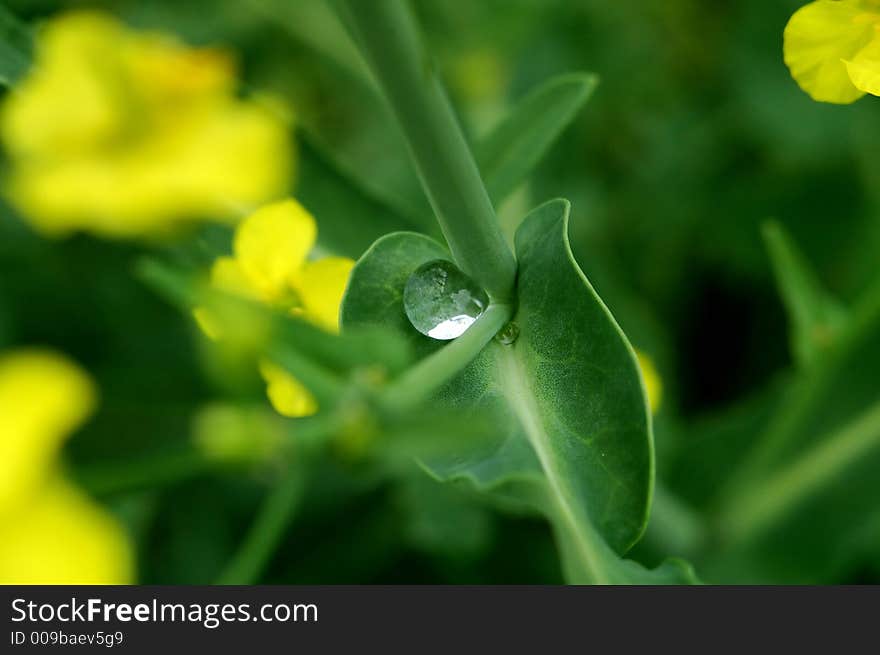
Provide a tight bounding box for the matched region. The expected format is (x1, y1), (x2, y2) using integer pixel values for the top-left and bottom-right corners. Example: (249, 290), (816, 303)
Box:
(196, 200), (354, 417)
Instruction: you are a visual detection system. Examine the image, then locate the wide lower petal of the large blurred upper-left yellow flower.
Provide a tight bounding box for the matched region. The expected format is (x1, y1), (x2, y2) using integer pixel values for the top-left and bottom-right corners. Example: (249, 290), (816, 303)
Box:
(6, 99), (292, 238)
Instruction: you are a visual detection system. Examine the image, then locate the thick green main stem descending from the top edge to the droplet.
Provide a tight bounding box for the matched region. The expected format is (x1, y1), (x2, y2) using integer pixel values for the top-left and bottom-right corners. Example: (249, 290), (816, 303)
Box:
(338, 0), (516, 302)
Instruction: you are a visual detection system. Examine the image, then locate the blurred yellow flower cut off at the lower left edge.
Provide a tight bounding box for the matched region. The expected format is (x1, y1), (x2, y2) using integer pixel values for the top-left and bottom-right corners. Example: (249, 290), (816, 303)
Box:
(0, 350), (132, 584)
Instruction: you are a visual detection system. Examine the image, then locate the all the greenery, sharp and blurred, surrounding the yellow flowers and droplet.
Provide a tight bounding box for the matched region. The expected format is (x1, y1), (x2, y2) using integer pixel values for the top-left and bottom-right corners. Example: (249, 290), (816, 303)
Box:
(0, 0), (880, 584)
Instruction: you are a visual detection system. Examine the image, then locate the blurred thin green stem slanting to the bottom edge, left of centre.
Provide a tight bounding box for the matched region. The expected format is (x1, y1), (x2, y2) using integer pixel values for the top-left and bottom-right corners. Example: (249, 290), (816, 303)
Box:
(217, 468), (305, 585)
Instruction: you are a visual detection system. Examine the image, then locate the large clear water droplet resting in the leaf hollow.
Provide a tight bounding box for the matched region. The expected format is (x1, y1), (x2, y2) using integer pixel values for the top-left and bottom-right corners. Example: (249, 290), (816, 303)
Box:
(403, 259), (489, 340)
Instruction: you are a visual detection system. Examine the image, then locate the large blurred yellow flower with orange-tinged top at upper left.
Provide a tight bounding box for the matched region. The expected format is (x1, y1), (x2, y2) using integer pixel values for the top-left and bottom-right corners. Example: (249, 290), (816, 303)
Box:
(0, 11), (292, 237)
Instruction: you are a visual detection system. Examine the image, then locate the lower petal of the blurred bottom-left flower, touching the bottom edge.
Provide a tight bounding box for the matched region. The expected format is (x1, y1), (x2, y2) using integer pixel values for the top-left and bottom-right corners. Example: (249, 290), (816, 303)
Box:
(0, 478), (134, 584)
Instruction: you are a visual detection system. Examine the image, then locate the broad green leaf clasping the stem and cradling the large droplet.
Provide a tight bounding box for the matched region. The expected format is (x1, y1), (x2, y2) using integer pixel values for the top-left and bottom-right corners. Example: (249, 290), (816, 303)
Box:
(342, 201), (687, 582)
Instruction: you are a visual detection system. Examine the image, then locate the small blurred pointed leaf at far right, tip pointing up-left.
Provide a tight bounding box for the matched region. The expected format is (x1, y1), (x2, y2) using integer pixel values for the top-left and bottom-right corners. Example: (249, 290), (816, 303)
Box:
(763, 222), (846, 366)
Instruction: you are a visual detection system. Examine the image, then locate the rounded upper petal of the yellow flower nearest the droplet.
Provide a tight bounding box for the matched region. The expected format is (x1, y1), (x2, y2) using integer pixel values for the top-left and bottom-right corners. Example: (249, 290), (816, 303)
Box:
(233, 200), (317, 299)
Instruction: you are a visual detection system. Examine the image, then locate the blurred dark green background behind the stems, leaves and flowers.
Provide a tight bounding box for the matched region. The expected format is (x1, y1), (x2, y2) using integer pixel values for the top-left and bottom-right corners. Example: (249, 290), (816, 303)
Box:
(0, 0), (880, 583)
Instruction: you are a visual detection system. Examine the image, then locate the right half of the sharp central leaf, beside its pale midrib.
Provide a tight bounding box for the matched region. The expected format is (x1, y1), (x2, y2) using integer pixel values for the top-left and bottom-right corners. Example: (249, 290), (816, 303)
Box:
(496, 201), (653, 552)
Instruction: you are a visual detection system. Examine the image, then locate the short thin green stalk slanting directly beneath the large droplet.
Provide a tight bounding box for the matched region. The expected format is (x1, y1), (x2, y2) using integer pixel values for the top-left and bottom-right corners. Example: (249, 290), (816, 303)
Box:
(382, 304), (513, 412)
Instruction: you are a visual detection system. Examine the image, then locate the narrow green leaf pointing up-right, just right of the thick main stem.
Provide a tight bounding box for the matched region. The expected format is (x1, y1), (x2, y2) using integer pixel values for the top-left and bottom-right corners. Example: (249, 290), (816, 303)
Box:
(475, 73), (599, 206)
